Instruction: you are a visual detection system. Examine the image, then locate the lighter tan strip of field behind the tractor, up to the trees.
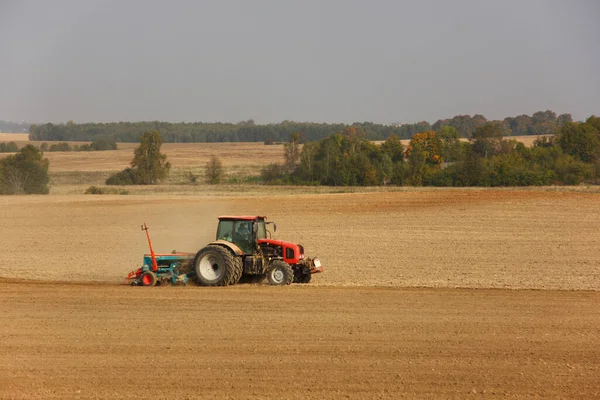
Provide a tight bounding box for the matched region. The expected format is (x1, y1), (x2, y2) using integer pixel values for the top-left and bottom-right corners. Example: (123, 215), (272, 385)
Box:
(0, 189), (600, 290)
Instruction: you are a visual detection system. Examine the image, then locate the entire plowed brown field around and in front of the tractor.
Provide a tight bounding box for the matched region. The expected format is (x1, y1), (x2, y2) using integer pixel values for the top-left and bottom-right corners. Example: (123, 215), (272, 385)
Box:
(0, 189), (600, 399)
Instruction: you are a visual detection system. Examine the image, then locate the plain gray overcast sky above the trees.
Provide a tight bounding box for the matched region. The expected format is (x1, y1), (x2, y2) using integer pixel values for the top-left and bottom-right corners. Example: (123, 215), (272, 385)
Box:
(0, 0), (600, 123)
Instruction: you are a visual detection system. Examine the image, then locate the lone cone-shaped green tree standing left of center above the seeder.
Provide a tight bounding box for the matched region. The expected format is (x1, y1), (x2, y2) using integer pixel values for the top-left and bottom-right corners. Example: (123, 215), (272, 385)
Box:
(131, 131), (171, 185)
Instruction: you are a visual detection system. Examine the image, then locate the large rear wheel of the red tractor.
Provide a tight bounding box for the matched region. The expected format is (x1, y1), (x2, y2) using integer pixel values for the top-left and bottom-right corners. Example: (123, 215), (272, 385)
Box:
(194, 245), (243, 286)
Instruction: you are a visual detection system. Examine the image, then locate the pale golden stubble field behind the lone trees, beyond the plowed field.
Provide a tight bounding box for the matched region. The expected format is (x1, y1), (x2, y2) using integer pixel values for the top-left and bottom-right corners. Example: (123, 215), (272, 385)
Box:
(0, 134), (552, 194)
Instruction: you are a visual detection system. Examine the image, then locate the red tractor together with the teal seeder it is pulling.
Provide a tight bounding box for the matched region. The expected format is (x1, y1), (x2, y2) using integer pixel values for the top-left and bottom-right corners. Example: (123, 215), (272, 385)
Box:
(126, 216), (323, 286)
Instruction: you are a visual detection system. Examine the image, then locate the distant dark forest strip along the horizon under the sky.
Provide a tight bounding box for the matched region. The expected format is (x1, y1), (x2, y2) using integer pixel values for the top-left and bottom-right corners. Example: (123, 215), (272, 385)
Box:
(29, 111), (572, 144)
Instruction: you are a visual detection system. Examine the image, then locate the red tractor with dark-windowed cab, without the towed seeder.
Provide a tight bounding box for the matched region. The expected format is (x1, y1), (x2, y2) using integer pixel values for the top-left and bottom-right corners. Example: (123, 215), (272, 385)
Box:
(193, 216), (323, 286)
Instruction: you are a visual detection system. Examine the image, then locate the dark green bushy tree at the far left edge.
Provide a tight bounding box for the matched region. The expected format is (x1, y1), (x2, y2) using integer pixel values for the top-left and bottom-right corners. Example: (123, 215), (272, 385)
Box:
(0, 144), (50, 194)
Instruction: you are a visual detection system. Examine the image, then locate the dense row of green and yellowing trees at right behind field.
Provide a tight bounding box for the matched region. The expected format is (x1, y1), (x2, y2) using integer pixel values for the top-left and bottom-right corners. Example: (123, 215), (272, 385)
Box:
(268, 116), (600, 186)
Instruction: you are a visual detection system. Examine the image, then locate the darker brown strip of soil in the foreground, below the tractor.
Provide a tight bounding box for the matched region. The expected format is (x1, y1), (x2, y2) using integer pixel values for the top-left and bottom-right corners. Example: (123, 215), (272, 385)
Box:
(0, 283), (600, 399)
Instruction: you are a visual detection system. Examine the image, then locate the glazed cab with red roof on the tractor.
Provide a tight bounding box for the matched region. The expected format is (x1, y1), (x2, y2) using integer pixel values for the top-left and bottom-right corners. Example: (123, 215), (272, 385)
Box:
(217, 216), (267, 254)
